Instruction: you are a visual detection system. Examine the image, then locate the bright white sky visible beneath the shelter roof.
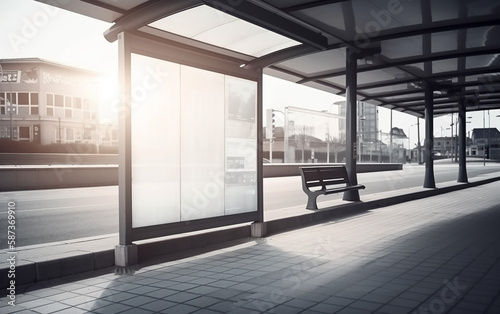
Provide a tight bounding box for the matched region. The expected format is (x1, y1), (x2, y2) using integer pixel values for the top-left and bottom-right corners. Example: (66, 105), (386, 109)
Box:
(0, 0), (500, 147)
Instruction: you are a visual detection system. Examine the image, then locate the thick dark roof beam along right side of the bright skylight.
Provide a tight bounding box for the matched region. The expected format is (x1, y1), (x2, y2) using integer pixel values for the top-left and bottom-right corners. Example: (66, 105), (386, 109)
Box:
(203, 0), (328, 50)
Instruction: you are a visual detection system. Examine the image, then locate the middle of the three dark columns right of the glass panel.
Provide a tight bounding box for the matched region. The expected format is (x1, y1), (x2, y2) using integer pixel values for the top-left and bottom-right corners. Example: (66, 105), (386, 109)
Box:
(424, 81), (436, 188)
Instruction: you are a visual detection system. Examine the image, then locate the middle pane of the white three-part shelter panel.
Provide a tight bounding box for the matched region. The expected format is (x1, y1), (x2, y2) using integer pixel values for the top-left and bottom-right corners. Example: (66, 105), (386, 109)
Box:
(181, 66), (224, 221)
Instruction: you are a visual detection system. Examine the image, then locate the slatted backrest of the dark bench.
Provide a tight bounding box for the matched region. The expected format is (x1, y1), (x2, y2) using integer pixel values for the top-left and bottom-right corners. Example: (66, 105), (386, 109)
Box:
(300, 166), (351, 189)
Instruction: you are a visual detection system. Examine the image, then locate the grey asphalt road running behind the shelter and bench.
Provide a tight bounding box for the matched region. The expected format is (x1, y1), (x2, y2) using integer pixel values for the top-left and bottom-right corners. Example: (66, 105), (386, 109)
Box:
(0, 163), (500, 249)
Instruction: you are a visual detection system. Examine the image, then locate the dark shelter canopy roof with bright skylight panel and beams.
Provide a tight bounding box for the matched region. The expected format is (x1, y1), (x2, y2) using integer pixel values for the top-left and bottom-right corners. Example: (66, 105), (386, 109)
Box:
(39, 0), (500, 117)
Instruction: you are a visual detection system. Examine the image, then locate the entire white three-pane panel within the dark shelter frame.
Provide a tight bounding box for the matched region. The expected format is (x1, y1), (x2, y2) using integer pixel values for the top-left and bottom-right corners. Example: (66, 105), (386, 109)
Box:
(129, 54), (257, 228)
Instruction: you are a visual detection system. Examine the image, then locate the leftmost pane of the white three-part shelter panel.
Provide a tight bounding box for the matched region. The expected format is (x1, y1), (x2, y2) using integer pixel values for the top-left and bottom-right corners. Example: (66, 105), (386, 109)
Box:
(131, 54), (182, 228)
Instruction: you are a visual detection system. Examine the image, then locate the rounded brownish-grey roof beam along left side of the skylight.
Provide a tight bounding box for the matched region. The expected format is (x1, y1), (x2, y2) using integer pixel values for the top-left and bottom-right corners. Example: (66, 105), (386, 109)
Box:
(104, 0), (202, 42)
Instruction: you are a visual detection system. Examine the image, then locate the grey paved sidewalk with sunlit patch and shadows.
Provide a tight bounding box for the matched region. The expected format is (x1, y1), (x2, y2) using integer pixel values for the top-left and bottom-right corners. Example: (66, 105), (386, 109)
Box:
(0, 182), (500, 314)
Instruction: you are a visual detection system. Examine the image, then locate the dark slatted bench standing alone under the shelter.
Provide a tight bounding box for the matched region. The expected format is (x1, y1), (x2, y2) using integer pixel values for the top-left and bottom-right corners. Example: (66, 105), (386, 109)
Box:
(300, 166), (365, 209)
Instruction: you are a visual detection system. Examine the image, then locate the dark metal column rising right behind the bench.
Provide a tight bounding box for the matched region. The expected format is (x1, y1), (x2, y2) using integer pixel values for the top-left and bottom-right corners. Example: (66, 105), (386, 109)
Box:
(343, 47), (360, 201)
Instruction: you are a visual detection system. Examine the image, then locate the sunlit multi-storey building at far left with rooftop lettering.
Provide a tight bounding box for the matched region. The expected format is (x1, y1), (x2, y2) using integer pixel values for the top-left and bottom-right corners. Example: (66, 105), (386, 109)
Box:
(0, 58), (117, 145)
